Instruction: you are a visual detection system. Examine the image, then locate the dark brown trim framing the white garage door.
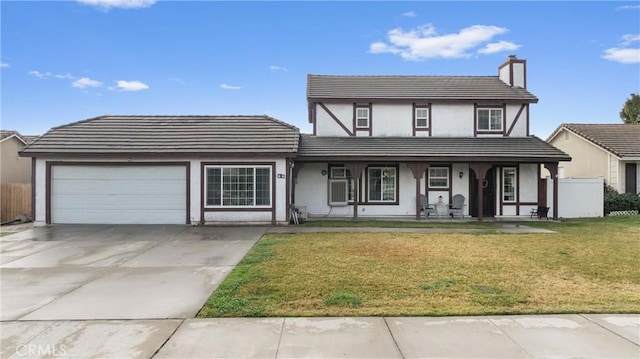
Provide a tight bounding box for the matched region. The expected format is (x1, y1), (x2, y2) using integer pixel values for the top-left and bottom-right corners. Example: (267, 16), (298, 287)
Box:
(45, 161), (191, 224)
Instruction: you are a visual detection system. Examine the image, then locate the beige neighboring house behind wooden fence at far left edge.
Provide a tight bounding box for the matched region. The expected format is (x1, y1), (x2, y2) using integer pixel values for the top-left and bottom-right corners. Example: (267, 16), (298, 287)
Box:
(0, 130), (37, 184)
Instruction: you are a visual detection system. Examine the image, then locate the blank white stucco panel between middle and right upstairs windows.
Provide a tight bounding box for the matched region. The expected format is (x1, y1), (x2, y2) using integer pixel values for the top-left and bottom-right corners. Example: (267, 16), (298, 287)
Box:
(431, 103), (473, 137)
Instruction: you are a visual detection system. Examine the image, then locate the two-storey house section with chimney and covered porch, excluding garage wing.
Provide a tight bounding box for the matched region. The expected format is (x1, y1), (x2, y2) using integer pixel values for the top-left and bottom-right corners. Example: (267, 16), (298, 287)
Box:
(293, 56), (571, 219)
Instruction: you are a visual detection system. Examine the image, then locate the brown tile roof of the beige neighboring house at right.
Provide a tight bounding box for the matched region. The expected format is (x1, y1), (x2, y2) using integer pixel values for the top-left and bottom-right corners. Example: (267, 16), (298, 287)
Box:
(547, 123), (640, 157)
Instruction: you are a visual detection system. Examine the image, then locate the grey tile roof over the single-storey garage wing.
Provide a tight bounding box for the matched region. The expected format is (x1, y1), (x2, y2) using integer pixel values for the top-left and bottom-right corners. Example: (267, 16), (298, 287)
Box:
(21, 116), (300, 157)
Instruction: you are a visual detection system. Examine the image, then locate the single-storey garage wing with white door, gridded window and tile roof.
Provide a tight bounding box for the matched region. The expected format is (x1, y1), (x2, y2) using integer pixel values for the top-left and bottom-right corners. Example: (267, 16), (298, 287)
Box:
(21, 116), (300, 225)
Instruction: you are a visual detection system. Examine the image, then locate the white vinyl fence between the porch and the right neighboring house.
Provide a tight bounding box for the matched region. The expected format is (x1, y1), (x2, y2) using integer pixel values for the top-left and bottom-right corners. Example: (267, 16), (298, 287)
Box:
(547, 177), (604, 218)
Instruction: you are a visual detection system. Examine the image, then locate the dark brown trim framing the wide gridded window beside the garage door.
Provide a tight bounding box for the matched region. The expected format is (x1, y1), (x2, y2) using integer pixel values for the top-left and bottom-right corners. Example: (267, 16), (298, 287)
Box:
(200, 162), (277, 224)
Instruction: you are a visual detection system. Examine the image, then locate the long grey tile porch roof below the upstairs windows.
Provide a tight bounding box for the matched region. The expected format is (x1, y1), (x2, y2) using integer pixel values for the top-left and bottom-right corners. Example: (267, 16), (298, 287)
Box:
(298, 135), (571, 163)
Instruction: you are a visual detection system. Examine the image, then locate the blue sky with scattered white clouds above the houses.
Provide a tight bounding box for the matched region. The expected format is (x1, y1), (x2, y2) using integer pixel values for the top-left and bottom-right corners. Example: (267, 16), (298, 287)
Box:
(0, 0), (640, 138)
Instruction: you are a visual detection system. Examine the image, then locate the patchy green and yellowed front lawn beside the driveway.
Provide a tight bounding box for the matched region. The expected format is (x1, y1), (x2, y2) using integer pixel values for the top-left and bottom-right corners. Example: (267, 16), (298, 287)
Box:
(199, 217), (640, 317)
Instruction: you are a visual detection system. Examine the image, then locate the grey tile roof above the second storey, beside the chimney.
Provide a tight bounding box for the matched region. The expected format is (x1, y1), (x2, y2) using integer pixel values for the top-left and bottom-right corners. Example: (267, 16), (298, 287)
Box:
(307, 75), (538, 103)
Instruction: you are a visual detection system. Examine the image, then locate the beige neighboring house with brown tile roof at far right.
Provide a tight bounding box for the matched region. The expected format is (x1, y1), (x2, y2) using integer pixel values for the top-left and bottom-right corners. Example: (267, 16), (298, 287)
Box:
(547, 123), (640, 193)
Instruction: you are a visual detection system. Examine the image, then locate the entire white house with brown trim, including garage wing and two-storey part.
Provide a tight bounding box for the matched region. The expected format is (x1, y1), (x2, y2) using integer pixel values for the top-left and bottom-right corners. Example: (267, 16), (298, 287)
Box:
(21, 56), (571, 224)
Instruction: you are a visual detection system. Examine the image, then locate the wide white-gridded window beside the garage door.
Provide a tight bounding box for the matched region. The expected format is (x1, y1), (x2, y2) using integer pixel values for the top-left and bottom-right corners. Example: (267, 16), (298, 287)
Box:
(205, 166), (271, 207)
